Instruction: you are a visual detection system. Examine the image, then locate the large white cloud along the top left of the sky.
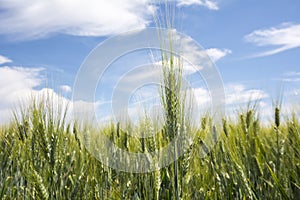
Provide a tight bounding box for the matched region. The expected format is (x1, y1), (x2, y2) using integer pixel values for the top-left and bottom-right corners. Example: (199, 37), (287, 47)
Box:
(0, 0), (155, 39)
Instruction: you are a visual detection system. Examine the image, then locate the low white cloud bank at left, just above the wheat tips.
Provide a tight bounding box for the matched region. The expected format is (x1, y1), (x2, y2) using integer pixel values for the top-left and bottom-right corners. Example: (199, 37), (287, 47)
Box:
(0, 66), (108, 125)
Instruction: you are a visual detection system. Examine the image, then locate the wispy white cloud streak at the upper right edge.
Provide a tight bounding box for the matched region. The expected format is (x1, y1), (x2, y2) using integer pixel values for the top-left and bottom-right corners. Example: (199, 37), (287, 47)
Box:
(245, 23), (300, 57)
